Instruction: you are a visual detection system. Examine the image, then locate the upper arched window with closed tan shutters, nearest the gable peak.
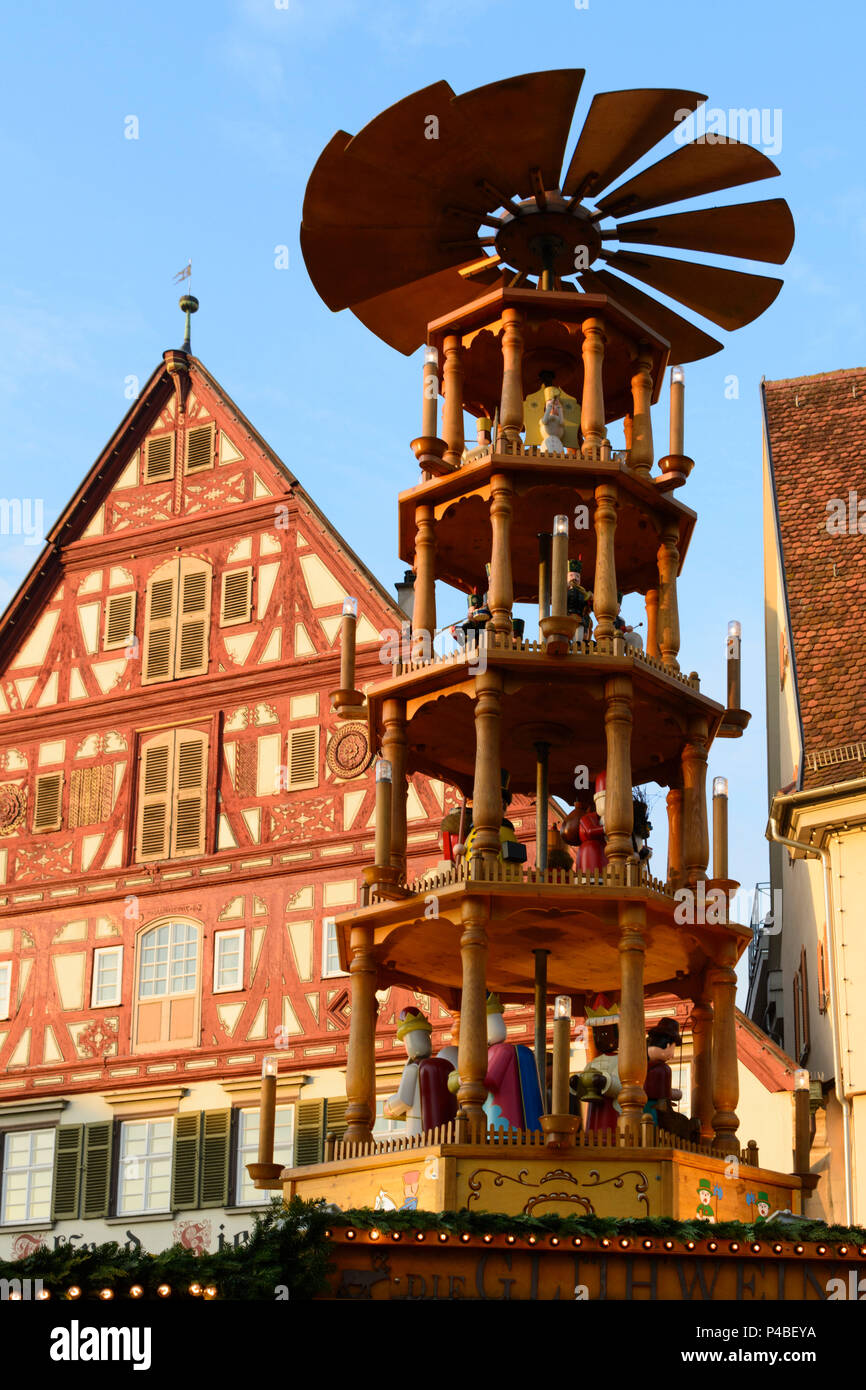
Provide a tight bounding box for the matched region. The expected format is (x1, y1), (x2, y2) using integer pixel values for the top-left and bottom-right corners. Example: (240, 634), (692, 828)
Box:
(142, 556), (211, 685)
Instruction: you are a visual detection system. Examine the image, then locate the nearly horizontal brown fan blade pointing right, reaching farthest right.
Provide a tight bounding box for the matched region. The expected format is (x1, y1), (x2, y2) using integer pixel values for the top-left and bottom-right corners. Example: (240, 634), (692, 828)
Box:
(616, 197), (794, 265)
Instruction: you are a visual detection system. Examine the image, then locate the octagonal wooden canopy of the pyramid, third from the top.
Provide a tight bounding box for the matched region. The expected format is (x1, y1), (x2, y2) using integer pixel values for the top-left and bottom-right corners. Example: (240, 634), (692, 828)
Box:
(367, 642), (724, 805)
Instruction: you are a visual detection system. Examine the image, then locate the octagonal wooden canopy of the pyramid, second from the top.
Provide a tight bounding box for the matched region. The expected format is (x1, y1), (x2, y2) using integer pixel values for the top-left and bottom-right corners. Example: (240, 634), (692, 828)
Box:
(399, 452), (696, 603)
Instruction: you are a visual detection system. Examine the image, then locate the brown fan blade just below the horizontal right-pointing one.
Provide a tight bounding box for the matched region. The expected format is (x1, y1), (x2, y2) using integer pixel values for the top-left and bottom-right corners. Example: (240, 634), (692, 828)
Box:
(605, 252), (783, 328)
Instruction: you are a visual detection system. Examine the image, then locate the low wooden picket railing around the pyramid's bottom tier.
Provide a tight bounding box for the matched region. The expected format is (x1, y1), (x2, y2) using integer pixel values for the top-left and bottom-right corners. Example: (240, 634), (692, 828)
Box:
(325, 1115), (759, 1168)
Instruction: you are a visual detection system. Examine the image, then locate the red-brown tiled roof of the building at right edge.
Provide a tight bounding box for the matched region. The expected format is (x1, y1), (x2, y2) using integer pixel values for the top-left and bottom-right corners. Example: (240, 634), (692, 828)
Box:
(763, 367), (866, 787)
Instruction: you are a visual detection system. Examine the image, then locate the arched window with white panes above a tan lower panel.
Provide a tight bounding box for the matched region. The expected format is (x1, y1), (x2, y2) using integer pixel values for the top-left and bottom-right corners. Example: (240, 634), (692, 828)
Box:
(135, 919), (202, 1052)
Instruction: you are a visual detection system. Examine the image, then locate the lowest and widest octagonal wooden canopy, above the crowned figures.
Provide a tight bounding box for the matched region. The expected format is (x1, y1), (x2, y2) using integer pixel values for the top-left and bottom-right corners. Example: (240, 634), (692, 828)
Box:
(336, 870), (751, 1009)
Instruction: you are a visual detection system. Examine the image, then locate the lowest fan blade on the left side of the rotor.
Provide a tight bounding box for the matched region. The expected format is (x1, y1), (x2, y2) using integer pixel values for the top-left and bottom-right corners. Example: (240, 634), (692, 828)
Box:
(352, 257), (506, 354)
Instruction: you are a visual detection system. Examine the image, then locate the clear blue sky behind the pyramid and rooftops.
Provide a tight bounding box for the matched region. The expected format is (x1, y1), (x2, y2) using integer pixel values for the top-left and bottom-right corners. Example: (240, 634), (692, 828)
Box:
(0, 0), (866, 978)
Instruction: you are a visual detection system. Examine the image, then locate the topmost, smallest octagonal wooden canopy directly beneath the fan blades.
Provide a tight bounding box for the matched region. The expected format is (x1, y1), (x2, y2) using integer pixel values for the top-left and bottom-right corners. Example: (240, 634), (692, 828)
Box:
(427, 289), (670, 421)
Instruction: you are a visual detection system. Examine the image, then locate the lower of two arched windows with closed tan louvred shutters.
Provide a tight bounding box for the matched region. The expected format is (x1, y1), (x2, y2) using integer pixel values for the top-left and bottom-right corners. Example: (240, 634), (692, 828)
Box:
(136, 728), (209, 863)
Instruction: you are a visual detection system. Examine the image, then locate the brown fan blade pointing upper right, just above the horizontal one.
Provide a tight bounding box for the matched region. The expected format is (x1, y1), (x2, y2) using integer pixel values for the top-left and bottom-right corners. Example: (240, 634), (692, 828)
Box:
(598, 136), (778, 217)
